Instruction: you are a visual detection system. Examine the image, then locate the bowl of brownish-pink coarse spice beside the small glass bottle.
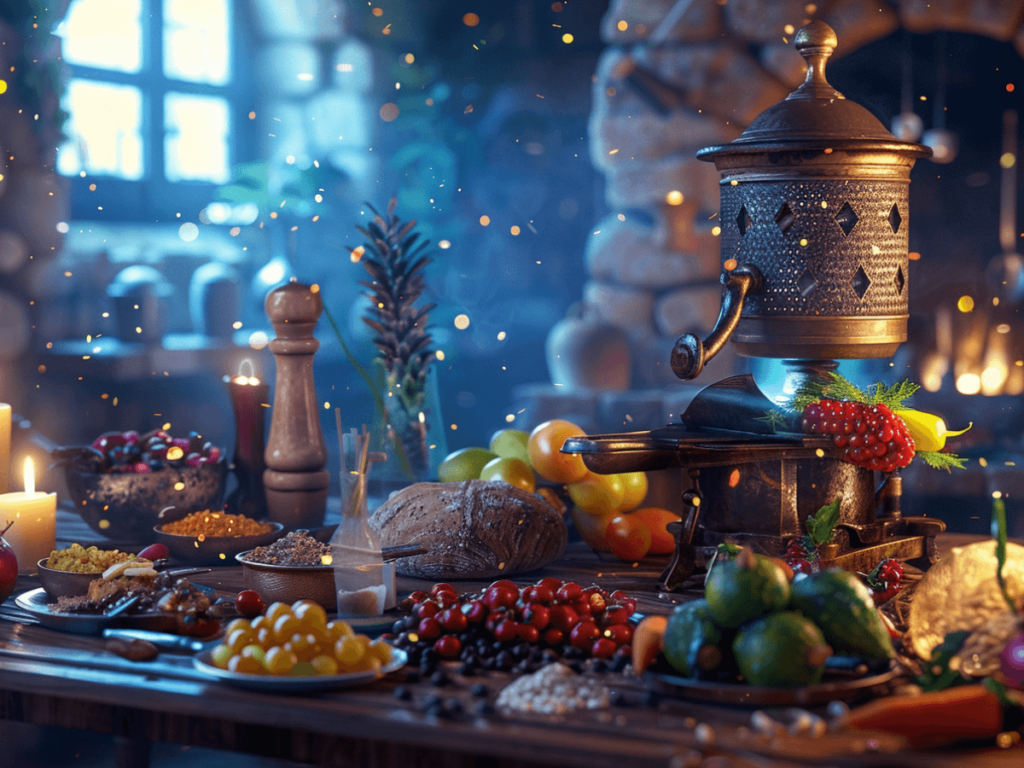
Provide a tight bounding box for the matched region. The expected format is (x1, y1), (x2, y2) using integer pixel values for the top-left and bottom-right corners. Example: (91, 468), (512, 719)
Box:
(234, 530), (338, 610)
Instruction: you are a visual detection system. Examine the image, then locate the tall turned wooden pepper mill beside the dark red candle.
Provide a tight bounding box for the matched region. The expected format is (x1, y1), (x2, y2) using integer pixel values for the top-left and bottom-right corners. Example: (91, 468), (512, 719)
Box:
(263, 278), (331, 530)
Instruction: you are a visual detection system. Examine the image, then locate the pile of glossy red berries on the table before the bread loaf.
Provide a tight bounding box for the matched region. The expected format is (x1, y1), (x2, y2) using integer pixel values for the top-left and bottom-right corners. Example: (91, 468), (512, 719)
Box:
(395, 577), (636, 660)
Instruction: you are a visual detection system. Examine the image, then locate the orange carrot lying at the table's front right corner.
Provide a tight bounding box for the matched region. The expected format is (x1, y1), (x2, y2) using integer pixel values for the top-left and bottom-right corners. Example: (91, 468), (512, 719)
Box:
(846, 683), (1002, 748)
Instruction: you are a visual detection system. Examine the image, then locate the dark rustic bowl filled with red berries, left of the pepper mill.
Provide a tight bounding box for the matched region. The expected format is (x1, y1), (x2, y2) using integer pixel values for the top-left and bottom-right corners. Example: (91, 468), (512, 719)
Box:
(53, 429), (227, 542)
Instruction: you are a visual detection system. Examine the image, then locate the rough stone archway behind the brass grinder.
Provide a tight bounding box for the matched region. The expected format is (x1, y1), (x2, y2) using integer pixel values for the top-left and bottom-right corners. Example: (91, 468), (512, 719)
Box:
(583, 0), (1024, 388)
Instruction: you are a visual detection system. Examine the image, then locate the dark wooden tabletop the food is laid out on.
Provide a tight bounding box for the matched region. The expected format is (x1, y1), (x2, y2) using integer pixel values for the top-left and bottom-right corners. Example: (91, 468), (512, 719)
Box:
(0, 513), (1024, 768)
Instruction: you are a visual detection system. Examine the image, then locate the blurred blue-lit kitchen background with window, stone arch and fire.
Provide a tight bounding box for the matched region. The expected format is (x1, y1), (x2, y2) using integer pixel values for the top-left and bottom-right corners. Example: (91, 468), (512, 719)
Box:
(0, 0), (1024, 535)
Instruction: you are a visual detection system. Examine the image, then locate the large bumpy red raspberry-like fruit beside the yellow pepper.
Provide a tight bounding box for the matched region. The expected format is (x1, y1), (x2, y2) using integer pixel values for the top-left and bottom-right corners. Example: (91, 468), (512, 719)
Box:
(803, 399), (913, 472)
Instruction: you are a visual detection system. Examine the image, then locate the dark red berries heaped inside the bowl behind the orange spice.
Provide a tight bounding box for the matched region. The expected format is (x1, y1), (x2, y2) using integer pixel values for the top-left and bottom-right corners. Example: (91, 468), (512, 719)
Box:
(92, 429), (220, 473)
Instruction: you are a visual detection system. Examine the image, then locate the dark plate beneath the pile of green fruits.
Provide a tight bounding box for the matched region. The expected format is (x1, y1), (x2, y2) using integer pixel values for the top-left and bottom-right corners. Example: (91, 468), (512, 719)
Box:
(644, 668), (898, 707)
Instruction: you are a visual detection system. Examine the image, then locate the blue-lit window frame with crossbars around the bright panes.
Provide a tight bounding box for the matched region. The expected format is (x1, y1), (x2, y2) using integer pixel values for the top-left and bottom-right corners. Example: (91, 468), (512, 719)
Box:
(63, 0), (258, 222)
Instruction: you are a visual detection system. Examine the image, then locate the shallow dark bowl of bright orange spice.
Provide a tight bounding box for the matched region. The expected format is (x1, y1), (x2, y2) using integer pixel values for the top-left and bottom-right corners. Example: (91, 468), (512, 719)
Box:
(153, 509), (284, 565)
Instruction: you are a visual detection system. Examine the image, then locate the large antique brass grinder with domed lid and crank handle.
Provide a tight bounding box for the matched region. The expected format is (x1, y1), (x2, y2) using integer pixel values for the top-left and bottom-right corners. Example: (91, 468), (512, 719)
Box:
(562, 20), (944, 590)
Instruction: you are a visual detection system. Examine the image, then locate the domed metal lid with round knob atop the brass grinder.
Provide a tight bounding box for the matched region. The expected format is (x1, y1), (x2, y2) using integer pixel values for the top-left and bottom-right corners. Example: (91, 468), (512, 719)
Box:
(697, 19), (932, 160)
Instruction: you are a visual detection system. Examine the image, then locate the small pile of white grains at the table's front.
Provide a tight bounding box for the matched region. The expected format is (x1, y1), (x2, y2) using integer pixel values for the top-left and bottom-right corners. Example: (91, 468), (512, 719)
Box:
(497, 663), (611, 715)
